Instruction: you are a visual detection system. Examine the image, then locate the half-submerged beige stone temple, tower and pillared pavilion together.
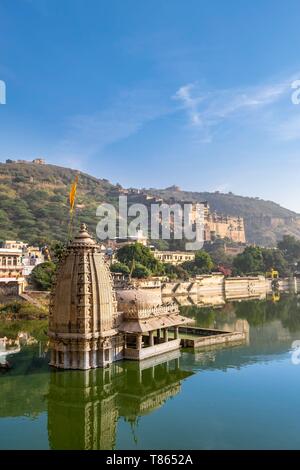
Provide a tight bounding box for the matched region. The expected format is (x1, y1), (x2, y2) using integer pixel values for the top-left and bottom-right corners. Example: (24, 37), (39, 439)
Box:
(48, 224), (191, 369)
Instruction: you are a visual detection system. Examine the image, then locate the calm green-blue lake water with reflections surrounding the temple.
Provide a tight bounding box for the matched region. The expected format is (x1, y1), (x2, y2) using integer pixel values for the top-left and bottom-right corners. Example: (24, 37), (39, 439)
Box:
(0, 296), (300, 449)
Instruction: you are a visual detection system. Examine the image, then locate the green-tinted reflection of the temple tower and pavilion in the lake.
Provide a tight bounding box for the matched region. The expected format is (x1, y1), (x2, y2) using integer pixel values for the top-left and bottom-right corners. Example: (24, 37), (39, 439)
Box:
(48, 351), (192, 449)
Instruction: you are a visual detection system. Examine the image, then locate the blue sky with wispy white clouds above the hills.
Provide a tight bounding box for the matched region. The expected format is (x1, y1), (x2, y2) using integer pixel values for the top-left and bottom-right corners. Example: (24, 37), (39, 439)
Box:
(0, 0), (300, 212)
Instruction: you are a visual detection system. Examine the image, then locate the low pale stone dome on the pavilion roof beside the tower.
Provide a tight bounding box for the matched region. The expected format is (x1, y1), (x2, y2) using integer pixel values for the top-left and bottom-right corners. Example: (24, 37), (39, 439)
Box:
(117, 288), (162, 313)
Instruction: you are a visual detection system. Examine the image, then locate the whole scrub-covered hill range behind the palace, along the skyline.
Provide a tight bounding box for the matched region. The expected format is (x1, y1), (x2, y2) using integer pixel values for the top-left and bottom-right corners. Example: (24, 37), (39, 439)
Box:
(0, 162), (300, 246)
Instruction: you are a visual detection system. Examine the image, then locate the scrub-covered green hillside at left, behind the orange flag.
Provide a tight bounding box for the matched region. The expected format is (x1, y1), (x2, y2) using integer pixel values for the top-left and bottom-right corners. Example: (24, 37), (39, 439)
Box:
(0, 163), (117, 244)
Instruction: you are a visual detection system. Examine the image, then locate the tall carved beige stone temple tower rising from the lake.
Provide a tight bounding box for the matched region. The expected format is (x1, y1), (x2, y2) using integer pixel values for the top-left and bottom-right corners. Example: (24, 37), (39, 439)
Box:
(48, 224), (123, 369)
